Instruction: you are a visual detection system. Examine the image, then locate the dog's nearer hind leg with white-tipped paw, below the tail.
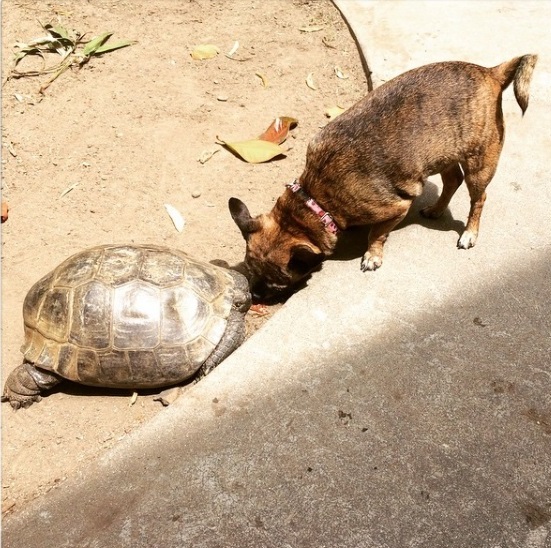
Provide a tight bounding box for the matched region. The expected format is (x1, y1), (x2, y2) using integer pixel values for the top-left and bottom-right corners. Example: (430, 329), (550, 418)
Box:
(457, 143), (503, 249)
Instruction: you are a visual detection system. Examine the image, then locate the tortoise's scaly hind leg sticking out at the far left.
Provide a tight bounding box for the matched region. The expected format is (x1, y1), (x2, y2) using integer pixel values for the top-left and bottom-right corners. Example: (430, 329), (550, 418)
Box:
(2, 362), (62, 409)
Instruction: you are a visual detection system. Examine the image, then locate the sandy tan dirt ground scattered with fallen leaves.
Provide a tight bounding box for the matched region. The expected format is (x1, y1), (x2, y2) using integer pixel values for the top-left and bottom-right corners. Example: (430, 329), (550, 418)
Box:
(1, 0), (367, 513)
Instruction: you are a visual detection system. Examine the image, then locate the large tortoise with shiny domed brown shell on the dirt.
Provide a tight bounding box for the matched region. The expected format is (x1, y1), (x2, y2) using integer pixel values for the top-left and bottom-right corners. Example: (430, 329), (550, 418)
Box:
(2, 245), (251, 409)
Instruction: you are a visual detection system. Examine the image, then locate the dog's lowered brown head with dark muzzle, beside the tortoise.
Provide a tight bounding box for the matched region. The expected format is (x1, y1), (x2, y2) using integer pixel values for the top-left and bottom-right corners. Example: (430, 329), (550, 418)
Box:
(229, 198), (325, 301)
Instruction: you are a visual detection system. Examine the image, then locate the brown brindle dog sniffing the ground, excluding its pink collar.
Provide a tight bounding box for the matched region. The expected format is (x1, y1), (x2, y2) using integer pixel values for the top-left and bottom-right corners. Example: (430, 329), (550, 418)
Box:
(229, 55), (537, 299)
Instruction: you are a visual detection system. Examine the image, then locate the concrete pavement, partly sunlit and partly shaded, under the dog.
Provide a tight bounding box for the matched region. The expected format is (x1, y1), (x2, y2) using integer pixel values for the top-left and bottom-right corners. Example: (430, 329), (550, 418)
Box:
(3, 0), (551, 548)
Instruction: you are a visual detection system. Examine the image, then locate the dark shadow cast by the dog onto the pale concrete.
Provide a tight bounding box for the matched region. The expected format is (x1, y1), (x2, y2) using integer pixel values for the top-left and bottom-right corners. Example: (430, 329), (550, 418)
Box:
(330, 181), (465, 261)
